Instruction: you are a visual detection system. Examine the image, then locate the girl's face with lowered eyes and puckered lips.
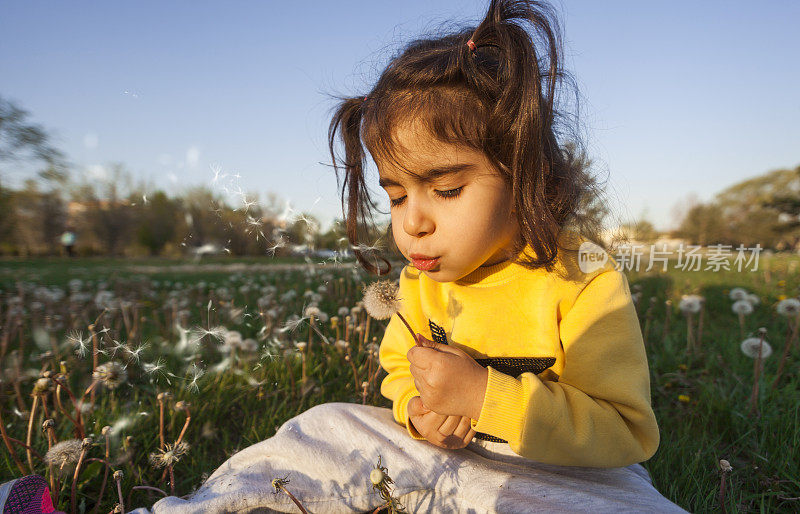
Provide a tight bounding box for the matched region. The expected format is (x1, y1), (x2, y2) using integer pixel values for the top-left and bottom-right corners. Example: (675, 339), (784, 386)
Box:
(377, 125), (518, 282)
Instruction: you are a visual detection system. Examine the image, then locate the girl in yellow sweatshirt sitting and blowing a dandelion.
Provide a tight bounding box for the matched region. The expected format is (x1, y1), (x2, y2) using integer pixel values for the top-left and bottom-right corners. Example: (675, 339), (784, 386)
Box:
(133, 0), (682, 513)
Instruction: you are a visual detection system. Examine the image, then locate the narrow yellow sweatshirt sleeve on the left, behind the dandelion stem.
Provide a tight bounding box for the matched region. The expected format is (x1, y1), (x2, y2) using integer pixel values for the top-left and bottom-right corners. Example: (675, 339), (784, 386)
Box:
(379, 267), (427, 439)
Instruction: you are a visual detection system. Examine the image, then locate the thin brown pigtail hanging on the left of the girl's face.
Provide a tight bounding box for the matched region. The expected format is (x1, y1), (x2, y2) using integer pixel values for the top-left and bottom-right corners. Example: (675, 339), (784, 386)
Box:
(328, 94), (392, 275)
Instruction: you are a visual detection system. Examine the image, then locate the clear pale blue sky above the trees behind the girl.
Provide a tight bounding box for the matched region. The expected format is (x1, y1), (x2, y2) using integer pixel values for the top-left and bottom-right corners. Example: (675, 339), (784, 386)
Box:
(0, 0), (800, 229)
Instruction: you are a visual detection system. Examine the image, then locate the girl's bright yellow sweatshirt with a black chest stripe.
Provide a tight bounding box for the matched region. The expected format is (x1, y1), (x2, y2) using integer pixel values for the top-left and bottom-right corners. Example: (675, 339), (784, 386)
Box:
(380, 238), (659, 467)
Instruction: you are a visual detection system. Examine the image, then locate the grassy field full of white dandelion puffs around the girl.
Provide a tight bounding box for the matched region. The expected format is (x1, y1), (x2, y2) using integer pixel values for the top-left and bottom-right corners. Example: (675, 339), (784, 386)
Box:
(0, 256), (800, 512)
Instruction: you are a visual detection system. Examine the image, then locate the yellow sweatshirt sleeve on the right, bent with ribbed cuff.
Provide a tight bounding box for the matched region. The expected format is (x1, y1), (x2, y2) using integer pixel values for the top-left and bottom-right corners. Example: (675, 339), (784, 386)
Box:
(473, 270), (659, 468)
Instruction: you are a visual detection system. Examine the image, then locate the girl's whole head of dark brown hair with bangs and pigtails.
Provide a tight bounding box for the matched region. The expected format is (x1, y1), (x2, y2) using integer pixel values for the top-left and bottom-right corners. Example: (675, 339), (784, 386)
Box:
(328, 0), (596, 275)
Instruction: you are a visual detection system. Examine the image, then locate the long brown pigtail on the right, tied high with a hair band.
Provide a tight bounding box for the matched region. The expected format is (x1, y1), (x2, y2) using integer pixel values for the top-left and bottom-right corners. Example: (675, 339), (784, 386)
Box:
(462, 0), (585, 267)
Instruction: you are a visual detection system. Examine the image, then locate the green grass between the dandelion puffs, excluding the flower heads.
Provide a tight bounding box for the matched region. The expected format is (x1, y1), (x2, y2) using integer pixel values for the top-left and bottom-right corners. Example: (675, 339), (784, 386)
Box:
(0, 256), (800, 512)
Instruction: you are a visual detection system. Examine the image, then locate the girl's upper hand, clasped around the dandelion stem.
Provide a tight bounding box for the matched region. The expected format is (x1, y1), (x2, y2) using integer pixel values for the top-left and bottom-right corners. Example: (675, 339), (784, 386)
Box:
(406, 334), (489, 420)
